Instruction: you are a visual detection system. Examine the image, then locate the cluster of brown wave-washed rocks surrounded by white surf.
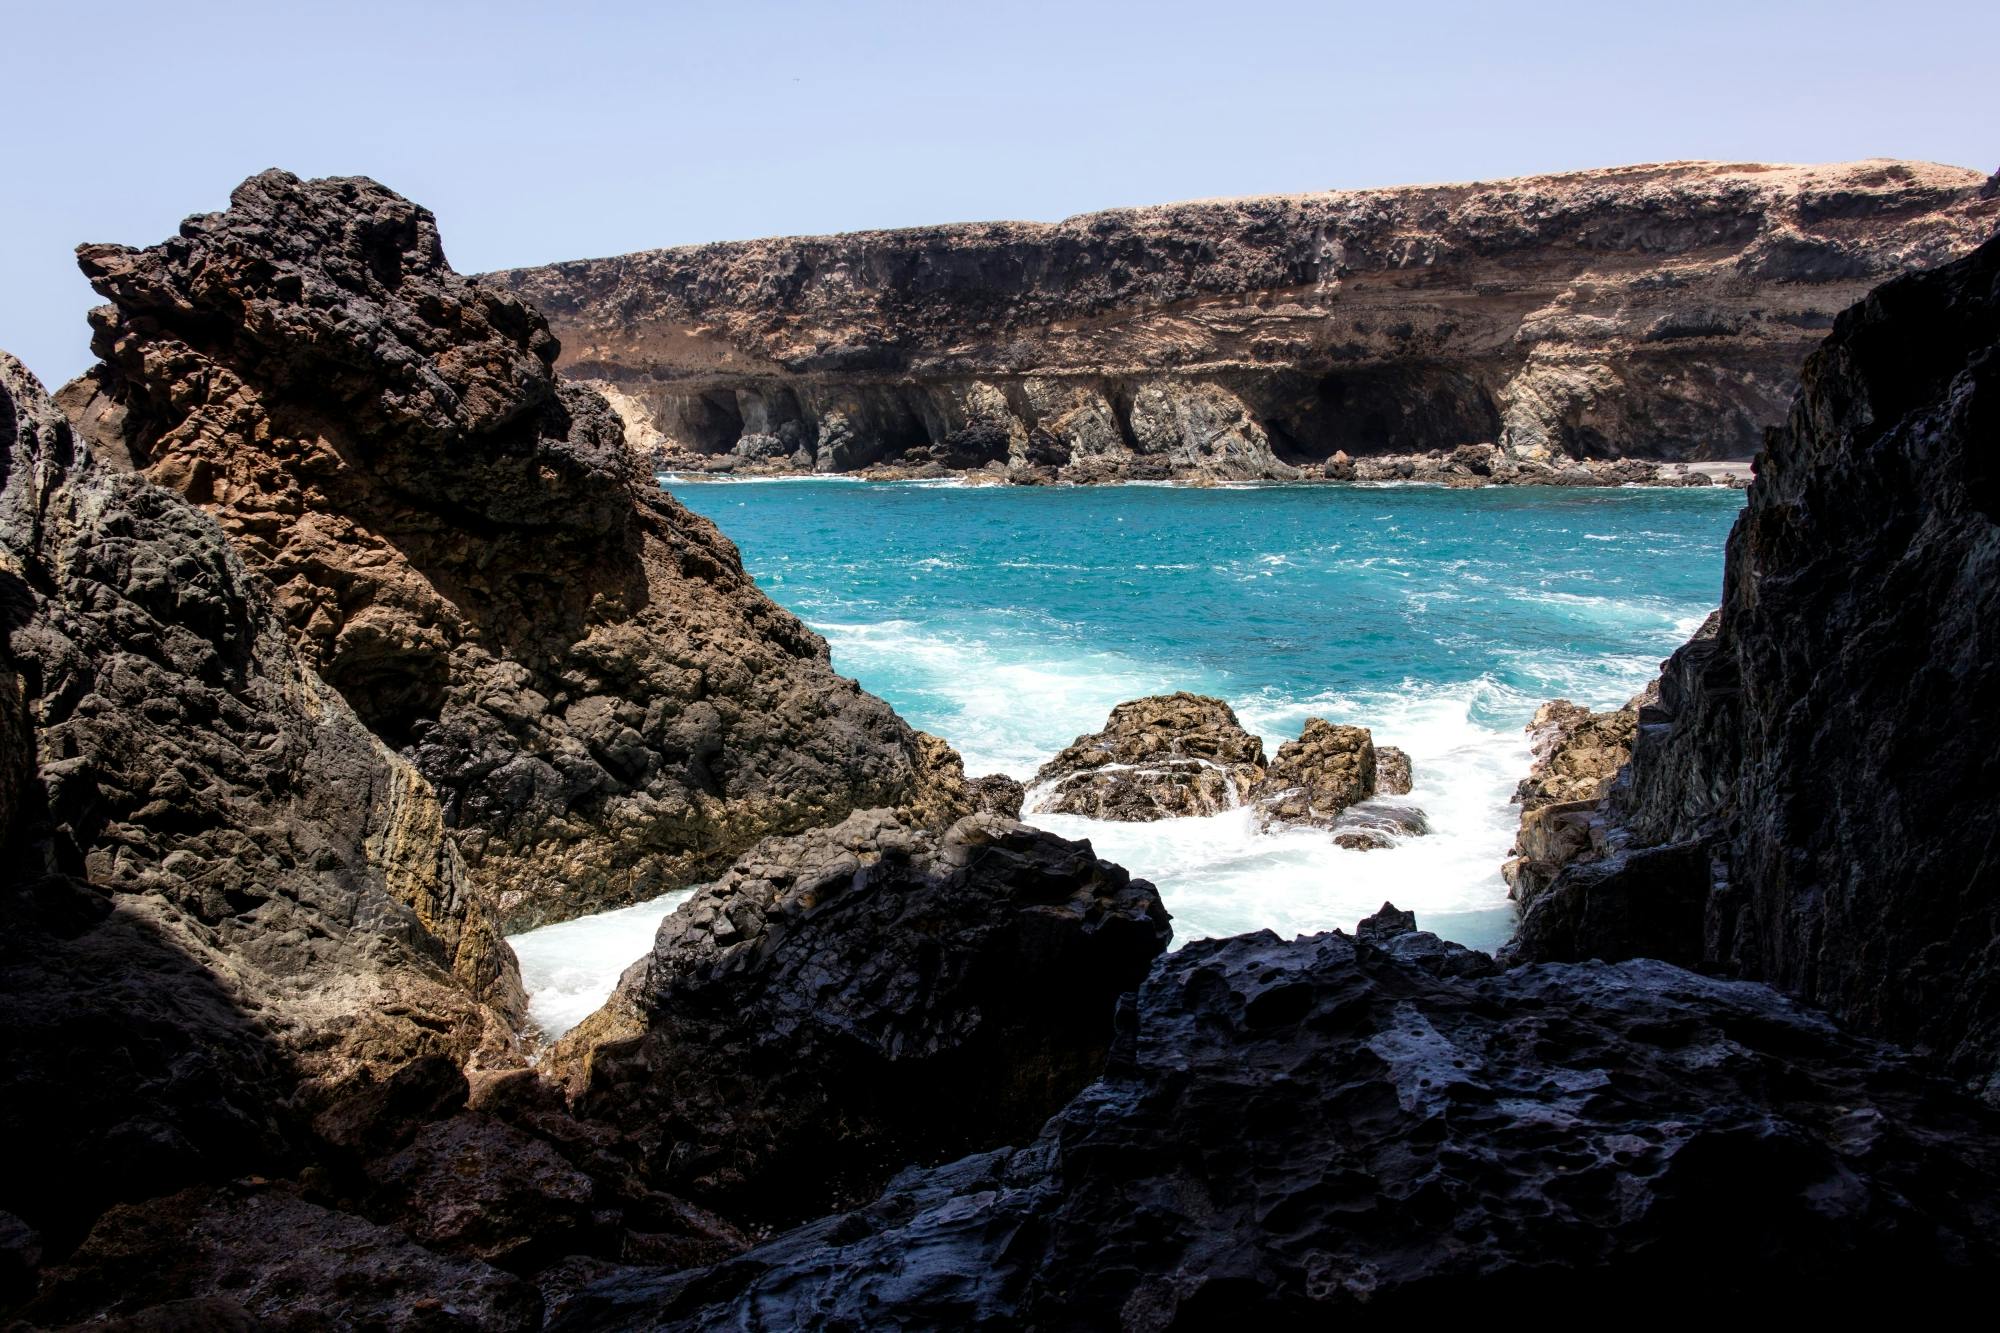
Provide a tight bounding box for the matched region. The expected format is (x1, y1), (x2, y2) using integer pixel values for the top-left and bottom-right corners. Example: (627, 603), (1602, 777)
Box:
(1030, 691), (1430, 851)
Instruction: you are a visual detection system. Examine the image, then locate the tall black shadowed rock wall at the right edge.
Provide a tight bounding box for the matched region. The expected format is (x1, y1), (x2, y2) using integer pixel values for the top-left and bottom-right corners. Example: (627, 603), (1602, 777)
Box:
(1514, 240), (2000, 1097)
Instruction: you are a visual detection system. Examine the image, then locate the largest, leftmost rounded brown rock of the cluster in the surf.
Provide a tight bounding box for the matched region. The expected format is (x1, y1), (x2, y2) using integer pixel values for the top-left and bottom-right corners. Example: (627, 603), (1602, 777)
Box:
(1030, 691), (1264, 821)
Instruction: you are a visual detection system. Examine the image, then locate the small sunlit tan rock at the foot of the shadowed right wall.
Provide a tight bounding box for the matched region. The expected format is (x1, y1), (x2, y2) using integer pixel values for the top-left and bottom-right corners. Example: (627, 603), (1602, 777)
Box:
(1500, 680), (1656, 896)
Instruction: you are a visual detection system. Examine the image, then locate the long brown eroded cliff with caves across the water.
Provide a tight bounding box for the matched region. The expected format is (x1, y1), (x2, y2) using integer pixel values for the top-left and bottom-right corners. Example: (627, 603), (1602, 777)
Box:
(490, 160), (2000, 480)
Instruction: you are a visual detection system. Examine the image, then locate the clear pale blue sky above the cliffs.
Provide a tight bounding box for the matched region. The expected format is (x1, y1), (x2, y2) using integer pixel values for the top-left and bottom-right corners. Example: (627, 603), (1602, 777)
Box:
(0, 0), (2000, 384)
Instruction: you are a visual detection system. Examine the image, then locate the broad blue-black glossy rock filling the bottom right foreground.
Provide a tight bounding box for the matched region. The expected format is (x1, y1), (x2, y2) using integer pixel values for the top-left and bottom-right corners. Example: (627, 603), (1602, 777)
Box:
(552, 909), (2000, 1333)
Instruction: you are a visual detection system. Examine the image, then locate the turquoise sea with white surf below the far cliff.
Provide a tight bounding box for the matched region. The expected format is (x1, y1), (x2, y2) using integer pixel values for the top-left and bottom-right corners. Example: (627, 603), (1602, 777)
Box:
(524, 480), (1742, 1040)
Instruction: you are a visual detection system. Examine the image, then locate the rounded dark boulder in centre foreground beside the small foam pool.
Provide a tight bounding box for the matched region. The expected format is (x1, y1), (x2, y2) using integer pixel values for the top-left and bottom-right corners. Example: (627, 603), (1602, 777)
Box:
(554, 811), (1168, 1221)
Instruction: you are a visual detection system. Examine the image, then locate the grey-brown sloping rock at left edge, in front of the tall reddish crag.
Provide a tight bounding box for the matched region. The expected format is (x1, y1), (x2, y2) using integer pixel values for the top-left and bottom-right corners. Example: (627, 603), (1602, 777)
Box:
(0, 354), (524, 1245)
